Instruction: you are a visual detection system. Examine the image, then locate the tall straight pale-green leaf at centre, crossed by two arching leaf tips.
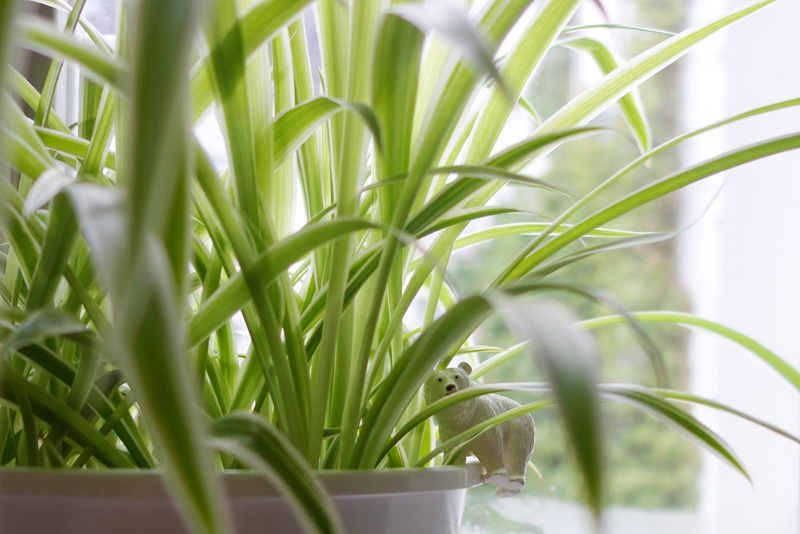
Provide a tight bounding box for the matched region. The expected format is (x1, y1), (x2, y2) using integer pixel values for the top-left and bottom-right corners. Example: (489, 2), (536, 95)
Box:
(309, 0), (383, 468)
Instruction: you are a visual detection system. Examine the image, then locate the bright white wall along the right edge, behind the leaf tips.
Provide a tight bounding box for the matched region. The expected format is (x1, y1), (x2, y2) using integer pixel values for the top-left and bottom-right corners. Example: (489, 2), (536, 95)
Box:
(680, 0), (800, 534)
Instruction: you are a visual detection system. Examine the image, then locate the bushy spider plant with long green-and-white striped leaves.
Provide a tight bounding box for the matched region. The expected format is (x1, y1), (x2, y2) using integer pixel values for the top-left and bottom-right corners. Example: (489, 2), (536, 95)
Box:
(0, 0), (800, 532)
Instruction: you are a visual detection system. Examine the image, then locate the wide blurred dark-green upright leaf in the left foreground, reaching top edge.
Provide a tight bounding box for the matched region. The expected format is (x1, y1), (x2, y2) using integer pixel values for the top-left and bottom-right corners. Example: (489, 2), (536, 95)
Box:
(128, 1), (197, 258)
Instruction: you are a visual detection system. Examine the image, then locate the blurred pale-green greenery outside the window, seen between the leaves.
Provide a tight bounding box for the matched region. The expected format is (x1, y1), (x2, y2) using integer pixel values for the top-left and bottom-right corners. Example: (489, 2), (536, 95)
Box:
(61, 0), (700, 533)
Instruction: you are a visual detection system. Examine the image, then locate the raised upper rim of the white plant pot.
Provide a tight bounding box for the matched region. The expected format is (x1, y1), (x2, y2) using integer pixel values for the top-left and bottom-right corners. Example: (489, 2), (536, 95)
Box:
(0, 463), (481, 499)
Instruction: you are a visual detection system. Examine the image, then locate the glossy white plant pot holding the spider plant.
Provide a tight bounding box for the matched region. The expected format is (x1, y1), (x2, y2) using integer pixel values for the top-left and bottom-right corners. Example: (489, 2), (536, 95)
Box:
(0, 464), (480, 534)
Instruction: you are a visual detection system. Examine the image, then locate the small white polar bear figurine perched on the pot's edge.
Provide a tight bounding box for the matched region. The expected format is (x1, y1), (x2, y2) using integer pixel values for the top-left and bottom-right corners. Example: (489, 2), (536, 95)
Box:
(424, 363), (536, 497)
